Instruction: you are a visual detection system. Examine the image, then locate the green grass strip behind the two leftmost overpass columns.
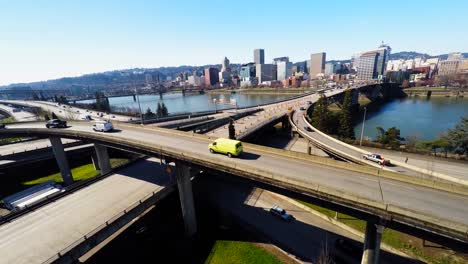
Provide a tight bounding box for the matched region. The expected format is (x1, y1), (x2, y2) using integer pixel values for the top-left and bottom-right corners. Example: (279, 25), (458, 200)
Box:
(22, 159), (129, 185)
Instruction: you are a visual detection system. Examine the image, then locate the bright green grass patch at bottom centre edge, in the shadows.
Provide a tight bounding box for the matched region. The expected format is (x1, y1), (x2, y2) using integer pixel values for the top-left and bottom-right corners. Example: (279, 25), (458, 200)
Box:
(205, 240), (282, 264)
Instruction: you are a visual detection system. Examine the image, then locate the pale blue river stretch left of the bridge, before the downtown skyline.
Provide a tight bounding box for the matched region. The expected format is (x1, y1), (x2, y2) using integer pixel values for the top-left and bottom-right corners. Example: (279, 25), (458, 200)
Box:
(79, 93), (293, 114)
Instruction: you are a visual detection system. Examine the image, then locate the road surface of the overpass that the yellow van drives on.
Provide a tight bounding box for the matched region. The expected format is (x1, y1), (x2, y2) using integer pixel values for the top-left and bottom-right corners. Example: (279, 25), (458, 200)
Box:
(8, 123), (468, 225)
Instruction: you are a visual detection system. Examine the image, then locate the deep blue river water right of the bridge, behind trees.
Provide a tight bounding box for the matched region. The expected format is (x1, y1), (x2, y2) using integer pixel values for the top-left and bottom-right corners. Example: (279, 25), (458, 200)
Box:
(354, 97), (468, 140)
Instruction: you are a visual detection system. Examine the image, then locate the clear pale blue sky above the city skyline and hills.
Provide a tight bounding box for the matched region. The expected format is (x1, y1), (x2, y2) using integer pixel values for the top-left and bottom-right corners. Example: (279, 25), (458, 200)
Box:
(0, 0), (468, 85)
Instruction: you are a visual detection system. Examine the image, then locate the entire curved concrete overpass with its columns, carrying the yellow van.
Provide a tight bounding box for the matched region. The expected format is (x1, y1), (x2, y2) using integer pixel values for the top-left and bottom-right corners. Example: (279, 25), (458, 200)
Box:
(0, 122), (468, 263)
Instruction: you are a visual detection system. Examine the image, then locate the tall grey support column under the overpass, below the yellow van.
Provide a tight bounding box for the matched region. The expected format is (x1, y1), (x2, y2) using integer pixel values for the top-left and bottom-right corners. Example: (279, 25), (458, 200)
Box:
(176, 161), (197, 236)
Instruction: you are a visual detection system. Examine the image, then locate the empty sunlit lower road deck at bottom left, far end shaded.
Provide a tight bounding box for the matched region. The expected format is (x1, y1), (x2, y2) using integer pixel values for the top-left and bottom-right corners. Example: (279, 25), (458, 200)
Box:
(0, 159), (174, 264)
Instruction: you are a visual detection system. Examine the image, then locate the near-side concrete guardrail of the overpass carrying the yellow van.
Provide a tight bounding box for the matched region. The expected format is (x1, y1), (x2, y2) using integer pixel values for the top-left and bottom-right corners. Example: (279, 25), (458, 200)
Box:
(0, 129), (468, 243)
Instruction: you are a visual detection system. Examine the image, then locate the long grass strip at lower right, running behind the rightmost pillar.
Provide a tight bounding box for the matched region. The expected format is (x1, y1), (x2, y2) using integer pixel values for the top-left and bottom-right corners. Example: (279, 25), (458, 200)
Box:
(296, 200), (465, 264)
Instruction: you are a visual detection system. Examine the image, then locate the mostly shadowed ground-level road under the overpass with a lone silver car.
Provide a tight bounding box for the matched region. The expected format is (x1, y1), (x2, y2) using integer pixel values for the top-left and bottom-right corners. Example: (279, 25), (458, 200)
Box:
(198, 179), (414, 263)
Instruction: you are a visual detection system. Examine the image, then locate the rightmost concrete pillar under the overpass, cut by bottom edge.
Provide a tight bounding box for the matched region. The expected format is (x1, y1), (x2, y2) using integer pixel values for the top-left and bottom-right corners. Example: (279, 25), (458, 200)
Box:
(361, 221), (384, 264)
